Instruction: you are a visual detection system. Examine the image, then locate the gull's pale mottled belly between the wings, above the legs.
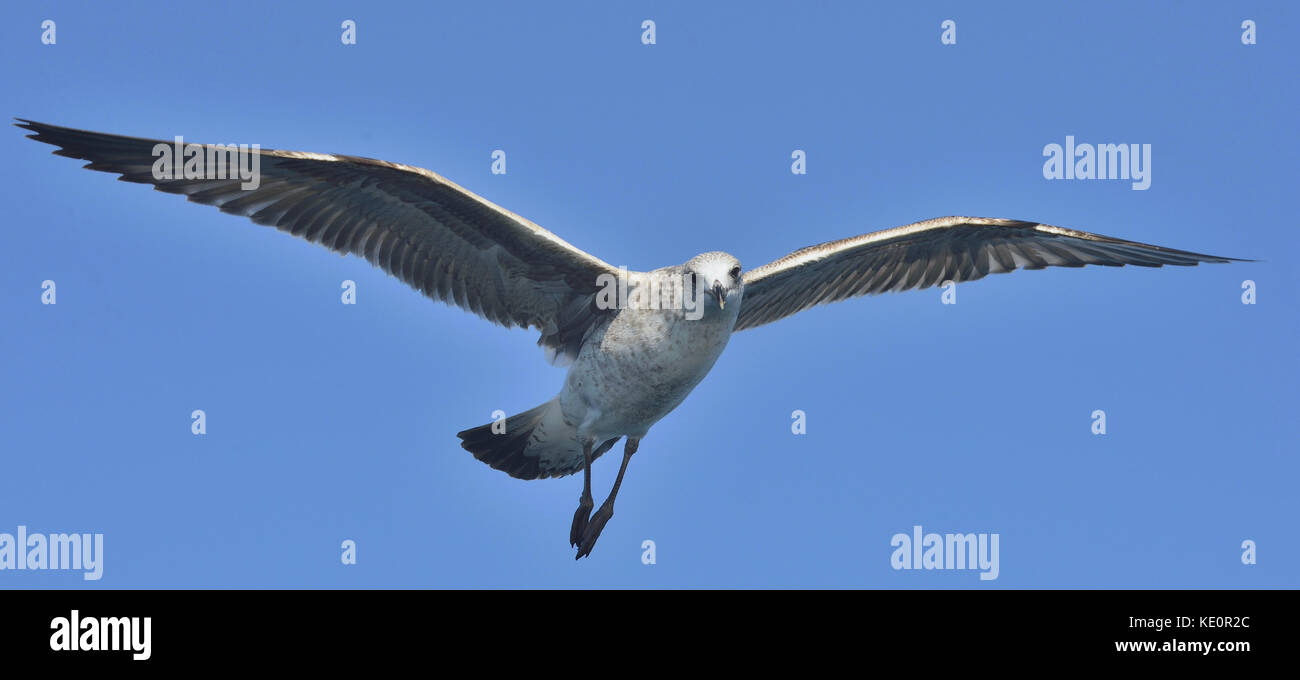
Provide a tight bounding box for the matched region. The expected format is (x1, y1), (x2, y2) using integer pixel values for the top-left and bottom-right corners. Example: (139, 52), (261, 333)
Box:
(560, 311), (735, 438)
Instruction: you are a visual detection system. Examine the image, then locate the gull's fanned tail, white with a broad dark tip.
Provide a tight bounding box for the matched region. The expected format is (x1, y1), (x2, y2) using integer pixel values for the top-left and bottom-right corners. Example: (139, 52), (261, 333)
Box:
(456, 398), (619, 480)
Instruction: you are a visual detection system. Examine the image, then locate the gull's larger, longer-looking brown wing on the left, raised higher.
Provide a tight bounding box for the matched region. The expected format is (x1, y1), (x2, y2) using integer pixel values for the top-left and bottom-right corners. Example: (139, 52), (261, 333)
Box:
(16, 118), (618, 359)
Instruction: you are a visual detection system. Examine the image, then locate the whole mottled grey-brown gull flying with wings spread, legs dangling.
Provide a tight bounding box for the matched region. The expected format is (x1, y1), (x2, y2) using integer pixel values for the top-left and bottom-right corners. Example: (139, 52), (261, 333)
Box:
(16, 118), (1240, 559)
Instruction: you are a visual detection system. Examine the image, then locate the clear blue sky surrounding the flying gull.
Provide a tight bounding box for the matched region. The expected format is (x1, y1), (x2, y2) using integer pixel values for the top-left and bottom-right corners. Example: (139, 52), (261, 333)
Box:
(0, 1), (1300, 588)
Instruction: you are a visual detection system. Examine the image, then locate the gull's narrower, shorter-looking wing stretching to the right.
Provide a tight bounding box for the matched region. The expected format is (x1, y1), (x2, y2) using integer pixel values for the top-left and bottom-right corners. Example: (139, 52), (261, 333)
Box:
(736, 217), (1239, 330)
